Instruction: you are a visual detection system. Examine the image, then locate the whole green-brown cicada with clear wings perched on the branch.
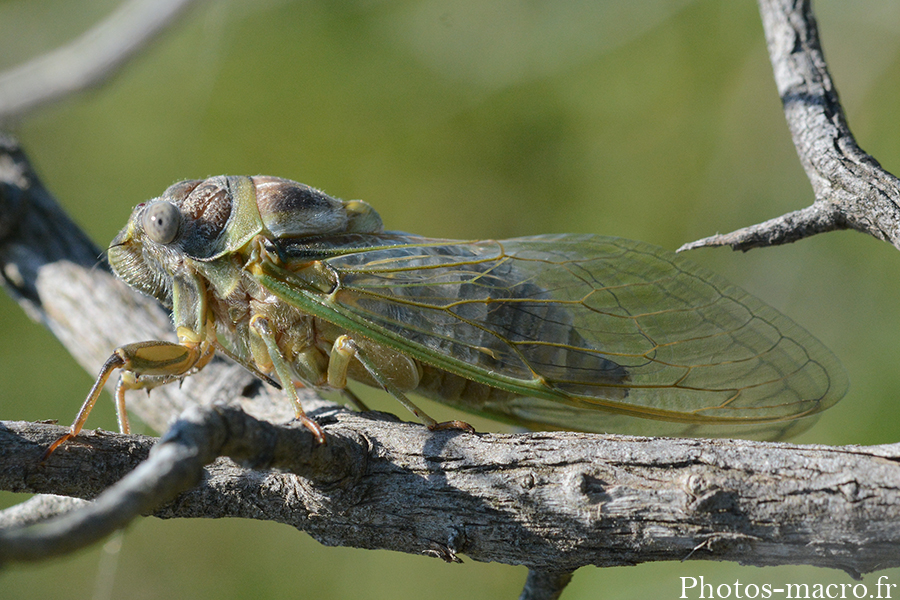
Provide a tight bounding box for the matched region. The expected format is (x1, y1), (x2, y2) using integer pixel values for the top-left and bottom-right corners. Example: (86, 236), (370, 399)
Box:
(45, 176), (847, 451)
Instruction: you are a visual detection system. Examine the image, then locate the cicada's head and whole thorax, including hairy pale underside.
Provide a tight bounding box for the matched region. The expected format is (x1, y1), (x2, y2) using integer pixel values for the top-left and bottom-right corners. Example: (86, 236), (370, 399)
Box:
(101, 176), (382, 394)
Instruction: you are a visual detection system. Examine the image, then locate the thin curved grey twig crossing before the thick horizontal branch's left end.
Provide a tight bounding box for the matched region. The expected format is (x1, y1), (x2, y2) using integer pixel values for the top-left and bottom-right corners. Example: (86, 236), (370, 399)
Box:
(0, 404), (352, 562)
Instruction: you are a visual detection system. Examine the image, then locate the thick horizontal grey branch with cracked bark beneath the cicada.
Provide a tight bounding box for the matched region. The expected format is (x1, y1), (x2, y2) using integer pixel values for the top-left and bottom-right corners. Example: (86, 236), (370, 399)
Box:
(0, 412), (900, 576)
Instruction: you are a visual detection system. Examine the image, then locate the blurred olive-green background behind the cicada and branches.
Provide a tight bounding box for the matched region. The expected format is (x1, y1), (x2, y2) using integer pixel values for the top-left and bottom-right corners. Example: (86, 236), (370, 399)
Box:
(0, 0), (900, 600)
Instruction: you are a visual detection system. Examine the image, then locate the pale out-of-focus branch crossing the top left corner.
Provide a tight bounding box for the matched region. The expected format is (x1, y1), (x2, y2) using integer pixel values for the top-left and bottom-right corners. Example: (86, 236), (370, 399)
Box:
(0, 0), (199, 120)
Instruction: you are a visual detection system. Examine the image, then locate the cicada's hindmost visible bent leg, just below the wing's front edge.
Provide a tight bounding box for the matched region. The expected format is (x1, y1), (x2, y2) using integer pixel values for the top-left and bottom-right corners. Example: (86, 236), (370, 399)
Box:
(328, 335), (475, 433)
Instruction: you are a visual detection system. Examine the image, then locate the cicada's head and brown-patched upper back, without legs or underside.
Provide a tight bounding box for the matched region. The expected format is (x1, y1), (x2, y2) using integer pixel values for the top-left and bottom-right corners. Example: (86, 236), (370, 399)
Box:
(109, 176), (383, 307)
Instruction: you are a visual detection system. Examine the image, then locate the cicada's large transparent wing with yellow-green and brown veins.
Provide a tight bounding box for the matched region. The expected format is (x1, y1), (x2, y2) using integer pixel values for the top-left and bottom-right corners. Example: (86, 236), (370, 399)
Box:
(274, 235), (847, 437)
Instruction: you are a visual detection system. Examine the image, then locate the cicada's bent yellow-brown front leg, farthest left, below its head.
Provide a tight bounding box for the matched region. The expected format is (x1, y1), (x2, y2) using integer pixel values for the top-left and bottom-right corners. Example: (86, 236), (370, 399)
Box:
(42, 338), (214, 460)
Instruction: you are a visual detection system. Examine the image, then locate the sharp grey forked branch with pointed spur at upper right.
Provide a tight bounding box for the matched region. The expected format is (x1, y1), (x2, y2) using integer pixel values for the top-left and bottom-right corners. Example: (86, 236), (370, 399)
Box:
(679, 0), (900, 252)
